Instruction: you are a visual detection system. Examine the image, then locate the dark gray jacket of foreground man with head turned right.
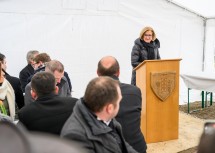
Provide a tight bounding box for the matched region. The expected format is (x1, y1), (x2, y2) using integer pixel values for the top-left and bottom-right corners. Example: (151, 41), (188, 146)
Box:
(61, 99), (137, 153)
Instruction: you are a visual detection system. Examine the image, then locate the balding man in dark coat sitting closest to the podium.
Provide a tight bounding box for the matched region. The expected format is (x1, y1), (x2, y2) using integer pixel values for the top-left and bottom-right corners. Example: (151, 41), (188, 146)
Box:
(97, 56), (147, 153)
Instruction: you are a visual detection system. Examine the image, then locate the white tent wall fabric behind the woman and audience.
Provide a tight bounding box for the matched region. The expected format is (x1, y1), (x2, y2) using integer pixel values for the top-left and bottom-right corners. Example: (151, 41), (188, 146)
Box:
(0, 0), (215, 103)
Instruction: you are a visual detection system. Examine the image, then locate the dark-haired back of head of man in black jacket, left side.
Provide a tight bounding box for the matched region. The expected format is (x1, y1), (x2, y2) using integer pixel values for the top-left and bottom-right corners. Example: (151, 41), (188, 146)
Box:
(31, 71), (56, 97)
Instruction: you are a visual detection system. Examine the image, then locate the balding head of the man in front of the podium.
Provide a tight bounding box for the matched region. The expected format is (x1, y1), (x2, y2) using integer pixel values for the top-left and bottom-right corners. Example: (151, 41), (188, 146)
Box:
(97, 56), (120, 77)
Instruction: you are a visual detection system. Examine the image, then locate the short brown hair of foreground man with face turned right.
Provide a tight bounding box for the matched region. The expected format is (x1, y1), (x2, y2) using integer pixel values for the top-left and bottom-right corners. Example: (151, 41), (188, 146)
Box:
(84, 77), (119, 112)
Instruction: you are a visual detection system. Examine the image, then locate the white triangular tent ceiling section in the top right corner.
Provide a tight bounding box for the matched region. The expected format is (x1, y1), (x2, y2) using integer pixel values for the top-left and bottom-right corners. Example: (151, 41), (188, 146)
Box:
(171, 0), (215, 18)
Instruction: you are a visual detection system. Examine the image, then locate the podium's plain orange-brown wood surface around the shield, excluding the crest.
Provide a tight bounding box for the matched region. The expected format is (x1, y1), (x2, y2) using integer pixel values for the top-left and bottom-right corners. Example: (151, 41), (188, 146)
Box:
(136, 59), (180, 143)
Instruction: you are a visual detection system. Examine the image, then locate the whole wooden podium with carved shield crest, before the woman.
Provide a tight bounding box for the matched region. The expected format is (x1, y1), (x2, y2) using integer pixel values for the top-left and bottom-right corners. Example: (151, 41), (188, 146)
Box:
(135, 59), (181, 143)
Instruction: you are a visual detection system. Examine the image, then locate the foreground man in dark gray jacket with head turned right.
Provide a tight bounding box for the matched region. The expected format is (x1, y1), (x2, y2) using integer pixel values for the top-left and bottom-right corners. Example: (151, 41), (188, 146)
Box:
(61, 77), (137, 153)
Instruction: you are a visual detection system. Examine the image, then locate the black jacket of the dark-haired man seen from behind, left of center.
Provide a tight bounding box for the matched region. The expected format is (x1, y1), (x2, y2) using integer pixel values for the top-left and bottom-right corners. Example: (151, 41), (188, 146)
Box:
(18, 94), (77, 135)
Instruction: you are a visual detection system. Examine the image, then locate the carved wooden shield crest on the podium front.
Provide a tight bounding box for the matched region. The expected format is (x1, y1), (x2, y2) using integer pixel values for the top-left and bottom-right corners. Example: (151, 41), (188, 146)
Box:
(151, 71), (176, 101)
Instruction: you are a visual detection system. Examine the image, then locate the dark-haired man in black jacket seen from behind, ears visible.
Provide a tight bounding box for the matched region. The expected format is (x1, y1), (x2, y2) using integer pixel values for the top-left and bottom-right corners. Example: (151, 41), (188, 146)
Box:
(18, 72), (77, 135)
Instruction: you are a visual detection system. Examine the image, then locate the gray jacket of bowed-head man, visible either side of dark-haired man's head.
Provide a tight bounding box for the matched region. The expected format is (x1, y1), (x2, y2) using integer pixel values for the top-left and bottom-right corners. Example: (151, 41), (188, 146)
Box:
(24, 77), (71, 105)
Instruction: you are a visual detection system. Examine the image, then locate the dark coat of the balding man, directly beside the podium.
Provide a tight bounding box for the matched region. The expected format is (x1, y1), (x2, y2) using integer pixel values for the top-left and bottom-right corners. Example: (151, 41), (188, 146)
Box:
(112, 76), (147, 153)
